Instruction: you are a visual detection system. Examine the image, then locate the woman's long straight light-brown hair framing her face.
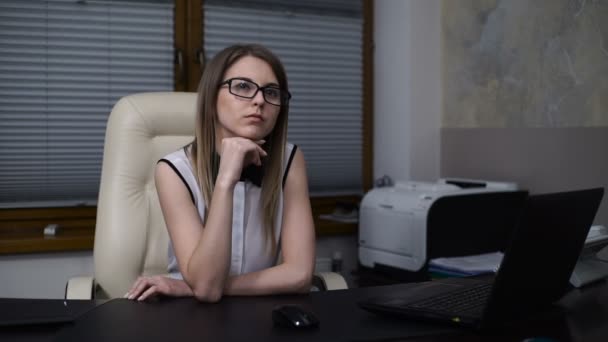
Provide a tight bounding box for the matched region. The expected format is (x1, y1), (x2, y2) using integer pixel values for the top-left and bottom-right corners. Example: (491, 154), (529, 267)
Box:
(190, 44), (289, 255)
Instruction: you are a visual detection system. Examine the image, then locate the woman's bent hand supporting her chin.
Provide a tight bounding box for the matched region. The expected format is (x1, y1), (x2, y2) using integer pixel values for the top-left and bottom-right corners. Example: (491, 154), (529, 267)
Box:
(215, 137), (267, 187)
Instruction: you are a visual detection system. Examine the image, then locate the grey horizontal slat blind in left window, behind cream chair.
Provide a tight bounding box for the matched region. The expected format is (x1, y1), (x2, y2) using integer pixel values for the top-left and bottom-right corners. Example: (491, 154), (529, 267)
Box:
(0, 0), (173, 206)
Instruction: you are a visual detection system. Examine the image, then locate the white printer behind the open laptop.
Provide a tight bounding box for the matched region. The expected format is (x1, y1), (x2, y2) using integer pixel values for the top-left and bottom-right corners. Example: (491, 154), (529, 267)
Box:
(359, 178), (517, 271)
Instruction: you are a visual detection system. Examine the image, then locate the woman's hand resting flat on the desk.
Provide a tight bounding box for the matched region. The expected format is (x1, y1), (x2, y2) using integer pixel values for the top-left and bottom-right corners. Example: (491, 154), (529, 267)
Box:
(124, 276), (193, 301)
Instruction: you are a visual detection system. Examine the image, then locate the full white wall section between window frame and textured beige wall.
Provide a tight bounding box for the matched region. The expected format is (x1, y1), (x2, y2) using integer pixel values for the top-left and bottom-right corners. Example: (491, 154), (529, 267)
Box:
(374, 0), (441, 181)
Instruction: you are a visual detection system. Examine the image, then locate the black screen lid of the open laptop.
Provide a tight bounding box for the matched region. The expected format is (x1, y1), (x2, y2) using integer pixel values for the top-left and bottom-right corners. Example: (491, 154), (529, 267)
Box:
(487, 188), (603, 320)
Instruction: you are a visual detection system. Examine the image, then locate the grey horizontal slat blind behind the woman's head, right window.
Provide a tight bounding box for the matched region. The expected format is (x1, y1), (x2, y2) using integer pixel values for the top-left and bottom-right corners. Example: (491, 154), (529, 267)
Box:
(203, 1), (363, 195)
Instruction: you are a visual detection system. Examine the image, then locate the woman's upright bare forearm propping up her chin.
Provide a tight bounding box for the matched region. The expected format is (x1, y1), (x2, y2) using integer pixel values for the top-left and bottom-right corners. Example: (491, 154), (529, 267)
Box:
(184, 184), (234, 302)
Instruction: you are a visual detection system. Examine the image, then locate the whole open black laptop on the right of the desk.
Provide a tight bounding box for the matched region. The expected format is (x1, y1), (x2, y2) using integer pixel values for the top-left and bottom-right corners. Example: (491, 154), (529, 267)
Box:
(358, 188), (604, 329)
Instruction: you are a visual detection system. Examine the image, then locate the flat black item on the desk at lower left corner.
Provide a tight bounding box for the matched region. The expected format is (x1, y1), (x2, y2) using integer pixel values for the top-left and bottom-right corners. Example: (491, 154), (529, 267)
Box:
(0, 298), (95, 328)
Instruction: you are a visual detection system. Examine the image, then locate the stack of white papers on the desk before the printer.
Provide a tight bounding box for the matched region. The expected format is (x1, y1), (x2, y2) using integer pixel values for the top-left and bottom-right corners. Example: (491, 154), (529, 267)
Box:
(429, 252), (503, 275)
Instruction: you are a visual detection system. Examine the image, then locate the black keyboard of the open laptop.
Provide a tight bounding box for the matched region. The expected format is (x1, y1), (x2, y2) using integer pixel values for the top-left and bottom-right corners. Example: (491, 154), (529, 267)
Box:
(407, 283), (492, 317)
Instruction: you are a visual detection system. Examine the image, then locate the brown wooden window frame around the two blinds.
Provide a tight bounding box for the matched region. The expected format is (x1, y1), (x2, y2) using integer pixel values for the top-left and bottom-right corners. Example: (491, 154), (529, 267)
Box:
(0, 0), (373, 255)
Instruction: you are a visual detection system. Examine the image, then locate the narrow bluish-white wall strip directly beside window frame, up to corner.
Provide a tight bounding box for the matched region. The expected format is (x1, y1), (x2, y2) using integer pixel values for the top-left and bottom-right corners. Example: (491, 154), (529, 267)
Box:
(374, 0), (412, 179)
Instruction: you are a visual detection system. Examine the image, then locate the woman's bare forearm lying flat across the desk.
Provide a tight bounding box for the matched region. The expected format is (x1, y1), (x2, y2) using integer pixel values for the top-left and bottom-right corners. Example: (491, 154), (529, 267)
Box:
(224, 263), (313, 296)
